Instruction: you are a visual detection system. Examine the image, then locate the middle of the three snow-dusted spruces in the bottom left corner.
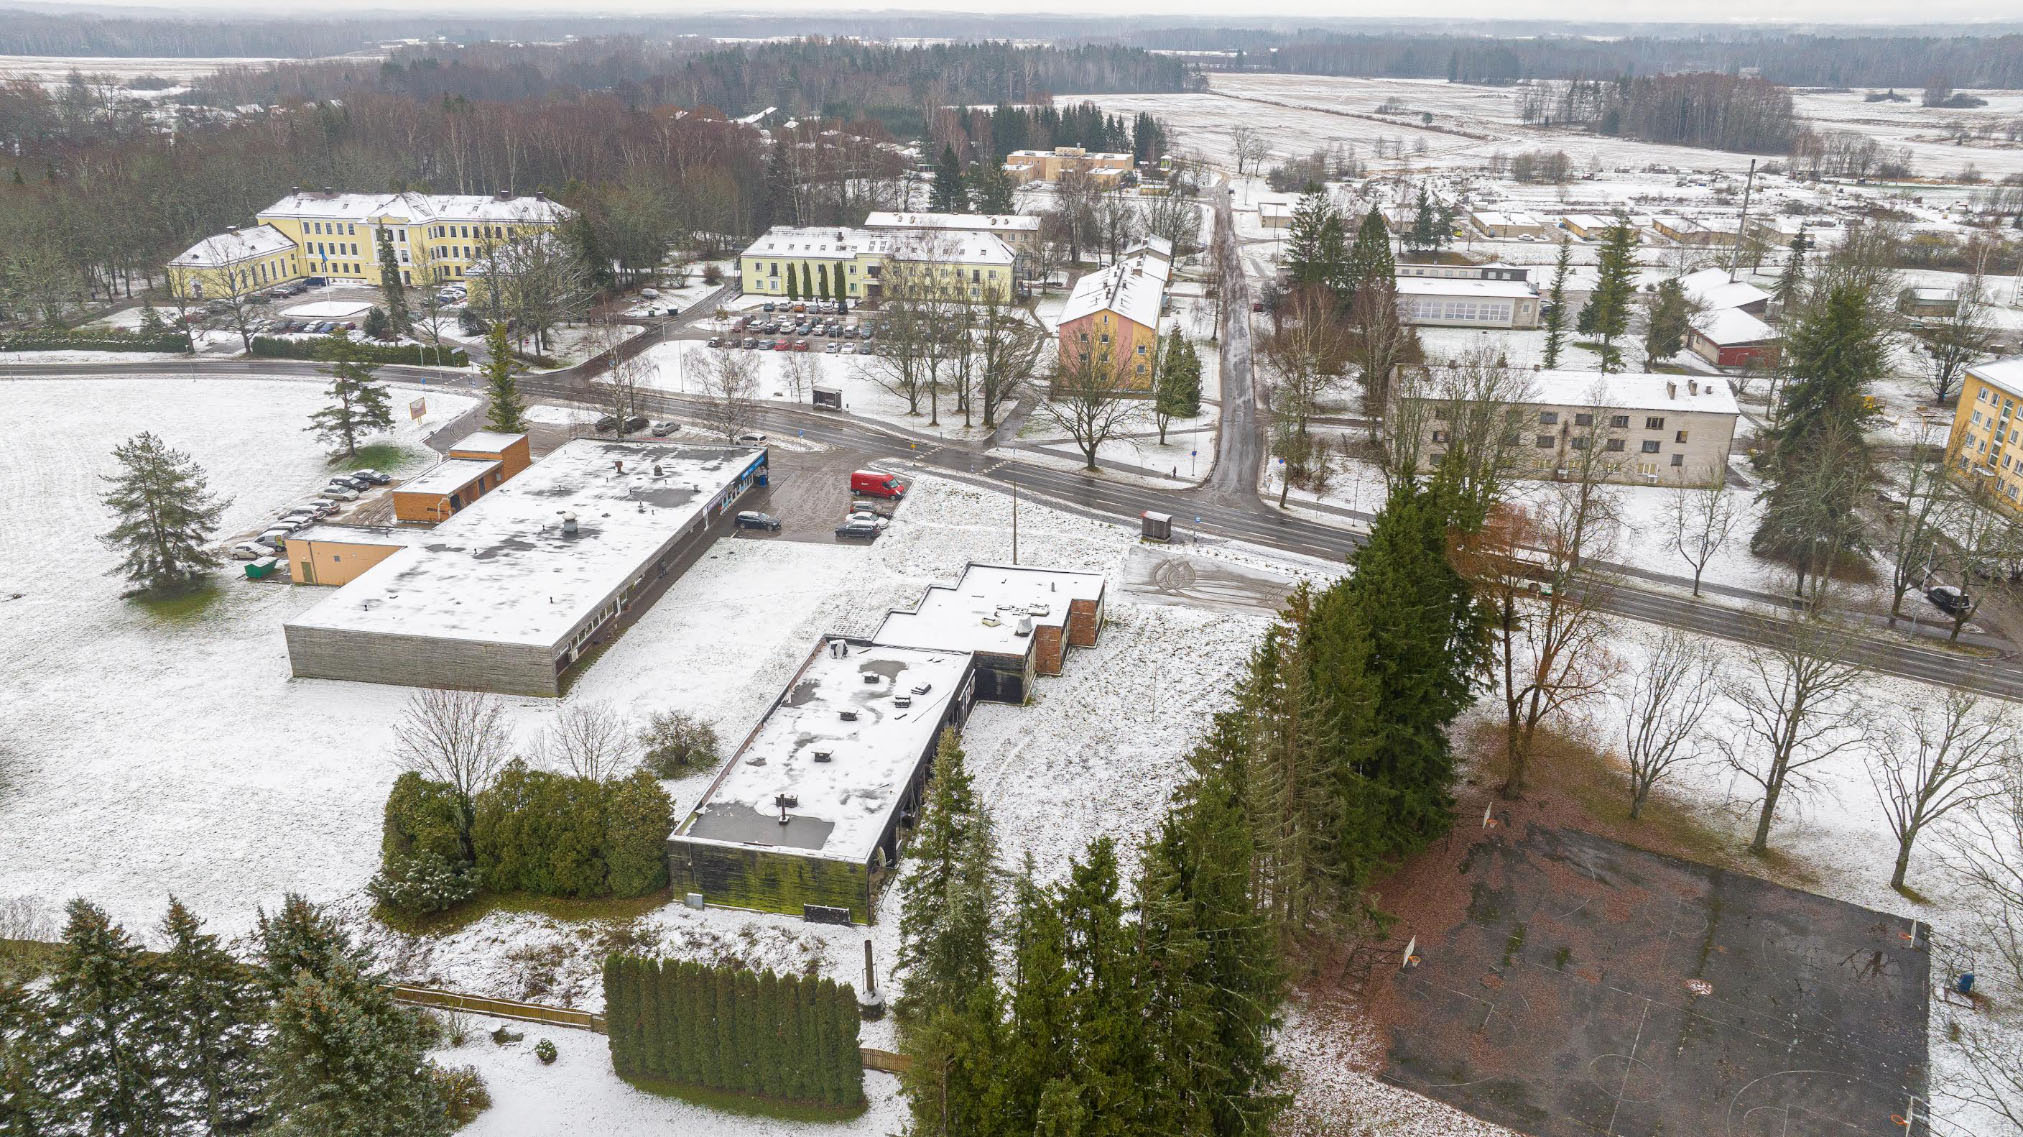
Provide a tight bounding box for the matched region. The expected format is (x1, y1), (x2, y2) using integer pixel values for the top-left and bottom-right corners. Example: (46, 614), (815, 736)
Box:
(158, 898), (267, 1135)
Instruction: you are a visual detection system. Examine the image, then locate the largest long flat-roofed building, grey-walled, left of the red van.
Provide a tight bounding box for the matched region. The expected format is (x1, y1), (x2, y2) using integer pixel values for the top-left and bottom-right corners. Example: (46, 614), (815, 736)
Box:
(285, 439), (767, 696)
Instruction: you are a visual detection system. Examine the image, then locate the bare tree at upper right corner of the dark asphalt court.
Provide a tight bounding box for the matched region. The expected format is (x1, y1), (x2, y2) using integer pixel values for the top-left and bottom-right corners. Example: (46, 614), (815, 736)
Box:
(1863, 690), (2017, 888)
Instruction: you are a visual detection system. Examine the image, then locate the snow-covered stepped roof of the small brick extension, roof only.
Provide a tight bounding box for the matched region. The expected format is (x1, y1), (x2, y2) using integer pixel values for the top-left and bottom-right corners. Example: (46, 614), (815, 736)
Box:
(872, 564), (1105, 655)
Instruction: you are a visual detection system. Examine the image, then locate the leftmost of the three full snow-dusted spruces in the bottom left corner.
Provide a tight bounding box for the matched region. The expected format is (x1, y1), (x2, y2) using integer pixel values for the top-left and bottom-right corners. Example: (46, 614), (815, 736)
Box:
(40, 900), (176, 1137)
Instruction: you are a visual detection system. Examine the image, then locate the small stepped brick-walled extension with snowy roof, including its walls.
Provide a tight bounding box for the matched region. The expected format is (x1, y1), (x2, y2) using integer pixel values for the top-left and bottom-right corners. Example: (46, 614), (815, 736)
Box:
(872, 564), (1105, 702)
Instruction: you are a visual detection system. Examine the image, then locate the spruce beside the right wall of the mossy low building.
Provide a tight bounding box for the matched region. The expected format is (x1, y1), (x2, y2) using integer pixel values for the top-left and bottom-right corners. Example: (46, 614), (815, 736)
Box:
(894, 730), (997, 1022)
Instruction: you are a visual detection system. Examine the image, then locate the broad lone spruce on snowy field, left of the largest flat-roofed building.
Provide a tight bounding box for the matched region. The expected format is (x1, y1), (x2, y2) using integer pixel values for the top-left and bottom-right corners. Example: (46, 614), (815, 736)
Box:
(99, 431), (229, 597)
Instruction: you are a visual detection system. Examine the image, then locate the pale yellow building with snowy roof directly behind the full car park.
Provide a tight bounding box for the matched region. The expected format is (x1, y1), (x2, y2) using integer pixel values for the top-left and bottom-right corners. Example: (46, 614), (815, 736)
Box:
(738, 225), (1016, 303)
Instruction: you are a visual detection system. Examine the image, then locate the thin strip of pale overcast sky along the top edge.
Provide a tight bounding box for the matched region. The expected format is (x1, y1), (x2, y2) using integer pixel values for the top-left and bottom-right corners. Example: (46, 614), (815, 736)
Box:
(59, 0), (2019, 24)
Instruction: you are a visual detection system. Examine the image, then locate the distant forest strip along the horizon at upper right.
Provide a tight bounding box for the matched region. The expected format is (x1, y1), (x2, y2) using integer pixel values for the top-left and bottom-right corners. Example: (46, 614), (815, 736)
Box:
(1246, 32), (2023, 89)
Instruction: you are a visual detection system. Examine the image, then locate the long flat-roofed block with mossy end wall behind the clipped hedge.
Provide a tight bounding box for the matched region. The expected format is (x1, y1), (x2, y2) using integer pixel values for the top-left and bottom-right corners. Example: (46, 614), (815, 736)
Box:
(668, 635), (975, 925)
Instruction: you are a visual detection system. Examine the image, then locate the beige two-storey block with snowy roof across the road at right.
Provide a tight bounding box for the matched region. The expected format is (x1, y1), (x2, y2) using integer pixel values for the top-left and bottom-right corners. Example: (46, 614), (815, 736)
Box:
(1420, 370), (1742, 486)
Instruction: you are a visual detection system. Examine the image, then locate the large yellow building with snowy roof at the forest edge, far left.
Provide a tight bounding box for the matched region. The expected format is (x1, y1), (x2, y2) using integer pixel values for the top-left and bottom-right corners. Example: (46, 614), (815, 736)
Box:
(168, 188), (575, 299)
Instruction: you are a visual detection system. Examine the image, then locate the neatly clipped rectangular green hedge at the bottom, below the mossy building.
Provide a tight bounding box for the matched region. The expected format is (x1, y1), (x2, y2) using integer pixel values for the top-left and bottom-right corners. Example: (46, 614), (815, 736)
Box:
(605, 955), (864, 1109)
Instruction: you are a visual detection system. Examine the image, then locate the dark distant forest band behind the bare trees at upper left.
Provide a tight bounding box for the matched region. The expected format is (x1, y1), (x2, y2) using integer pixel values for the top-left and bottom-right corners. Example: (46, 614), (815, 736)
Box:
(200, 36), (1202, 127)
